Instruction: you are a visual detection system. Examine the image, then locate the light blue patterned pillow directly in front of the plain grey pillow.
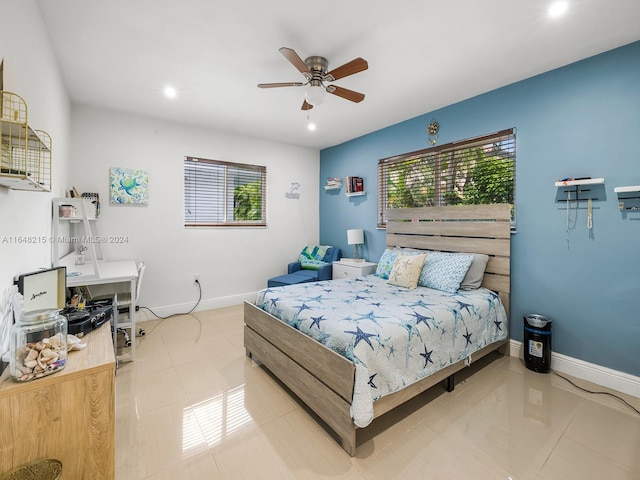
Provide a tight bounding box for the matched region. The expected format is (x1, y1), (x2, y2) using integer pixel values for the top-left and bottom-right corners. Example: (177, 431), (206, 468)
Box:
(418, 252), (473, 293)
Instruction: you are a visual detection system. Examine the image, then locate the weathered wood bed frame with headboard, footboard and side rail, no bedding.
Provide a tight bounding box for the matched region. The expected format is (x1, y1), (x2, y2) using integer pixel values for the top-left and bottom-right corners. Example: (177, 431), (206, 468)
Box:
(244, 204), (511, 456)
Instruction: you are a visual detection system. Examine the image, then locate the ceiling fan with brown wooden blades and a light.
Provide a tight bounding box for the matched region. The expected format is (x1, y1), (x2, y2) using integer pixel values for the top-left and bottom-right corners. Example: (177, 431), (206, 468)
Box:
(258, 47), (369, 110)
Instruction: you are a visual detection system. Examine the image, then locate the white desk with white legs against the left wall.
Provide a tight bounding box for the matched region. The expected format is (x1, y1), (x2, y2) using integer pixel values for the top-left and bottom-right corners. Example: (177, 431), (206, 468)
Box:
(66, 256), (138, 361)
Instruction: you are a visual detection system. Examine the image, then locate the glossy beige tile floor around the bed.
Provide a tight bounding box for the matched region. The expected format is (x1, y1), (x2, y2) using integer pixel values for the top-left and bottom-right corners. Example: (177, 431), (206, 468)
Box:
(116, 305), (640, 480)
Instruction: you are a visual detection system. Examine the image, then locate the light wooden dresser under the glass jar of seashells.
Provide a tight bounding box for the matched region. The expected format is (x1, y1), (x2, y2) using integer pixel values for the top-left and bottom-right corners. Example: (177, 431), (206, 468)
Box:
(0, 322), (115, 479)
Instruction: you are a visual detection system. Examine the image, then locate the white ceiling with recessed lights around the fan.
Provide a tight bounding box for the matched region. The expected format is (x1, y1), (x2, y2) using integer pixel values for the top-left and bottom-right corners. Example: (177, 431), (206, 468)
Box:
(37, 0), (640, 148)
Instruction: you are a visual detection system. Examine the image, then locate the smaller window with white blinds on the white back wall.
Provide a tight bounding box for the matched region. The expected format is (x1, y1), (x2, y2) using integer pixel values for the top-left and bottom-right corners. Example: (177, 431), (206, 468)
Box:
(184, 157), (267, 227)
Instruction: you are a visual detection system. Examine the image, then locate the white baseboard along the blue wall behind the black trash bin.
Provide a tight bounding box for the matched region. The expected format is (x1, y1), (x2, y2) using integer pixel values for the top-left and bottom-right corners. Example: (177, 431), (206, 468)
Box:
(510, 340), (640, 398)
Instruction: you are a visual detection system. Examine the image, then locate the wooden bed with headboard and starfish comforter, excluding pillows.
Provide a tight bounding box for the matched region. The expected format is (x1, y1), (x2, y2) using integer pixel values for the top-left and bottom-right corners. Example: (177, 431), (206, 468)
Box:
(244, 205), (510, 456)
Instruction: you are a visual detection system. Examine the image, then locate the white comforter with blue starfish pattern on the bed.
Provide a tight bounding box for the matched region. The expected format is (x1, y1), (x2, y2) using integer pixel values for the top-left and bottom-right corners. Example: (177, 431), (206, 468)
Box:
(255, 275), (507, 427)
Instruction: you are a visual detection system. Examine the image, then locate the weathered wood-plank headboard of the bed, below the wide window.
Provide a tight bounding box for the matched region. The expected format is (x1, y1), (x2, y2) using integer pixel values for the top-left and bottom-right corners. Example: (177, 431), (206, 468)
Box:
(387, 204), (511, 315)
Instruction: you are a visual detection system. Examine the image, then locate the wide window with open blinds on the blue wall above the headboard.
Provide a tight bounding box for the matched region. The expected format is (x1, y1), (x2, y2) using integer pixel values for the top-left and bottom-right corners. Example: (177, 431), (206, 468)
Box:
(378, 129), (516, 228)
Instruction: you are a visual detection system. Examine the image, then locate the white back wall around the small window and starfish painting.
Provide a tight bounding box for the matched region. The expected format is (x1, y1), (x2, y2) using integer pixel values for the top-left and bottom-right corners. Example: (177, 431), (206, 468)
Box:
(70, 105), (320, 316)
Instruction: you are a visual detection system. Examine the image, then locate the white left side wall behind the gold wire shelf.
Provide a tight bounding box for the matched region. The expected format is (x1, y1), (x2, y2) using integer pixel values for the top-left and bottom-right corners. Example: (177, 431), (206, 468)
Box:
(0, 0), (70, 289)
